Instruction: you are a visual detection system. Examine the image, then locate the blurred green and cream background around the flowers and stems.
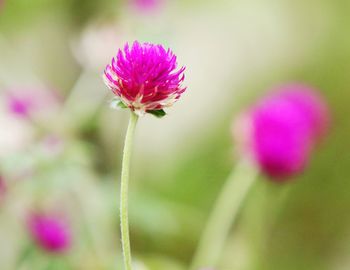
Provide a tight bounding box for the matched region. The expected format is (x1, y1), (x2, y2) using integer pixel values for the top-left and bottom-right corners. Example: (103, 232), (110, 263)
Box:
(0, 0), (350, 270)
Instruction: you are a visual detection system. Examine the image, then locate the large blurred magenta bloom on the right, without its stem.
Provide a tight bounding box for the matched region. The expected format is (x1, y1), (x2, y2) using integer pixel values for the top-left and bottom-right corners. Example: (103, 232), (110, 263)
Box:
(235, 84), (329, 181)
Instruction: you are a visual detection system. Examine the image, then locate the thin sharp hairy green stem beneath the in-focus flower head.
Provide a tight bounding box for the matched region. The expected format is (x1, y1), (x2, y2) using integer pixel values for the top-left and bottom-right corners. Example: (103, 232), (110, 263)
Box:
(120, 112), (138, 270)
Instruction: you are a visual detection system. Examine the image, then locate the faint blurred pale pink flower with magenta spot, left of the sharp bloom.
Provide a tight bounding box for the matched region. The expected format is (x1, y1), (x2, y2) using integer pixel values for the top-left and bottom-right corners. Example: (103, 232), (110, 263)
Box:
(6, 87), (59, 118)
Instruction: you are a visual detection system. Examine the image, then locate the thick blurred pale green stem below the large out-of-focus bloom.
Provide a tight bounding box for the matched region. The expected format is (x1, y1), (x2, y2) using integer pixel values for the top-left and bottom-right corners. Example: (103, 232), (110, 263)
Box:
(190, 160), (258, 270)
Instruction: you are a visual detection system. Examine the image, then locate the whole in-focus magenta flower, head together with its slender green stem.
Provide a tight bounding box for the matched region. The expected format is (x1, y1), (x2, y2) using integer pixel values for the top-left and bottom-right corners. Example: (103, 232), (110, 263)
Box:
(103, 41), (186, 270)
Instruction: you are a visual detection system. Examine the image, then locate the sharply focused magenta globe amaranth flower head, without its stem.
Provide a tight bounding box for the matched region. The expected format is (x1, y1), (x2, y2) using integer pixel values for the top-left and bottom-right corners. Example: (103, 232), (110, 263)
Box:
(104, 41), (186, 115)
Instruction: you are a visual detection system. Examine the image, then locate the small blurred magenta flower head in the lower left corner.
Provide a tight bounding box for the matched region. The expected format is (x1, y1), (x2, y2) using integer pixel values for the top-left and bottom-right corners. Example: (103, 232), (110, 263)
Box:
(27, 213), (71, 253)
